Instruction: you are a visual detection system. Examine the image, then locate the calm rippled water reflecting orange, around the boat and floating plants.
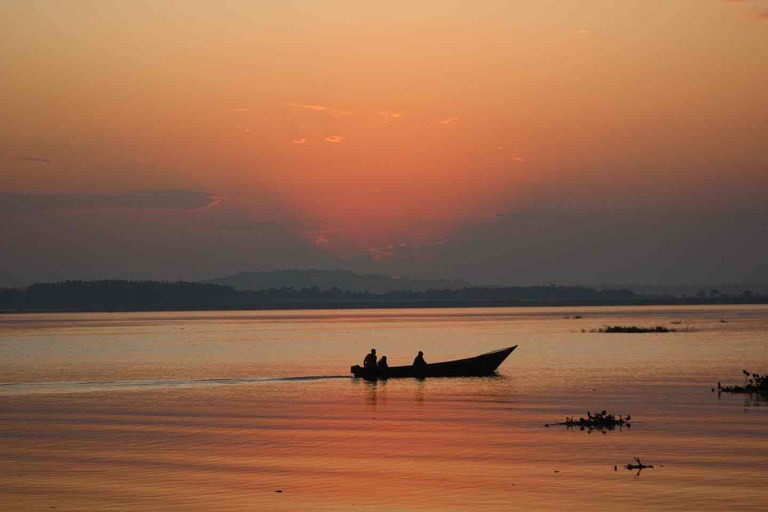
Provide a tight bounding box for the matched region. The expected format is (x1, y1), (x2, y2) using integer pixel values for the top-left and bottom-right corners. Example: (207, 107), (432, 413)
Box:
(0, 306), (768, 511)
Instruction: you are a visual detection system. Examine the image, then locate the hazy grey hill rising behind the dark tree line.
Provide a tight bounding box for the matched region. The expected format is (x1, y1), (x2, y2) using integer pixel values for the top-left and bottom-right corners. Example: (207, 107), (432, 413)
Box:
(206, 269), (472, 293)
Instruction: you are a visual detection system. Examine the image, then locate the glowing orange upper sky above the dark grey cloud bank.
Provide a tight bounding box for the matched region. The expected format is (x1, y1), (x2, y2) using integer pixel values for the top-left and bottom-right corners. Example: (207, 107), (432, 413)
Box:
(0, 0), (768, 284)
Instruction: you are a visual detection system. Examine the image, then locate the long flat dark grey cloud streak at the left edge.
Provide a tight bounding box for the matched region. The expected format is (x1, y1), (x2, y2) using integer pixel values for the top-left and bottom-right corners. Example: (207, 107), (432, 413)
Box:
(0, 190), (224, 213)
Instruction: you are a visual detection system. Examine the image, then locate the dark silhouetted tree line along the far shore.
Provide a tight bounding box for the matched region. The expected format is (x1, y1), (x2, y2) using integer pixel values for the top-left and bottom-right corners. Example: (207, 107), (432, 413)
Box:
(0, 280), (768, 311)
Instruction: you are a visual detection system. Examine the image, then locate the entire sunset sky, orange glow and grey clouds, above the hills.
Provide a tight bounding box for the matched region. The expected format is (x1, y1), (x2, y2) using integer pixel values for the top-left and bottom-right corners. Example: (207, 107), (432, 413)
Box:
(0, 0), (768, 286)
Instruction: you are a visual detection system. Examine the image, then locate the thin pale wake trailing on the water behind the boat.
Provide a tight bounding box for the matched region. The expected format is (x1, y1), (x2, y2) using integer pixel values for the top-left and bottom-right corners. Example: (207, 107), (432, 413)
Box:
(0, 375), (350, 396)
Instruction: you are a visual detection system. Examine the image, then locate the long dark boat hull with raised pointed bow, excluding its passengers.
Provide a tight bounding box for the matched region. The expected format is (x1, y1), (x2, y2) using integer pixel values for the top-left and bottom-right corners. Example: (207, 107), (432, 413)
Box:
(350, 345), (517, 380)
